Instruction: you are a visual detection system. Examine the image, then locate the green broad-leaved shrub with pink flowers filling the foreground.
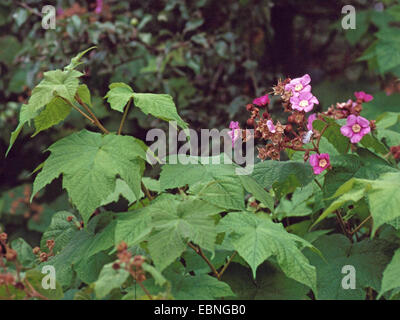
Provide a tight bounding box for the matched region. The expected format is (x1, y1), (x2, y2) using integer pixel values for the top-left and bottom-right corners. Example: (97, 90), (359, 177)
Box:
(0, 48), (400, 300)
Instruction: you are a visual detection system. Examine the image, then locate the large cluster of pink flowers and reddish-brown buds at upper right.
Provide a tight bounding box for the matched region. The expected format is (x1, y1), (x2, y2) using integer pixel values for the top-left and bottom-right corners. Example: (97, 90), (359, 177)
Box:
(233, 74), (375, 175)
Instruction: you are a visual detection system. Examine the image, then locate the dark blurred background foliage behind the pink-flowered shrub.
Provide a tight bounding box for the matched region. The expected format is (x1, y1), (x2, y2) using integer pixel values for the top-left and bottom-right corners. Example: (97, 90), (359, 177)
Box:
(0, 0), (400, 241)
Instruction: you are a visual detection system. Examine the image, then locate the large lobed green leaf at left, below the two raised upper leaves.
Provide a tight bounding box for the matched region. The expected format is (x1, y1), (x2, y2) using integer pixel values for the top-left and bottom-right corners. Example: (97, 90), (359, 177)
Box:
(33, 130), (146, 222)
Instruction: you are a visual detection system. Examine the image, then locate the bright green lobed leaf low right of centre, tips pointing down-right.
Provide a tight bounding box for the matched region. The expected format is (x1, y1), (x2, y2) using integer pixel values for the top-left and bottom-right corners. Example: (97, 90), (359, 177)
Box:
(218, 212), (316, 290)
